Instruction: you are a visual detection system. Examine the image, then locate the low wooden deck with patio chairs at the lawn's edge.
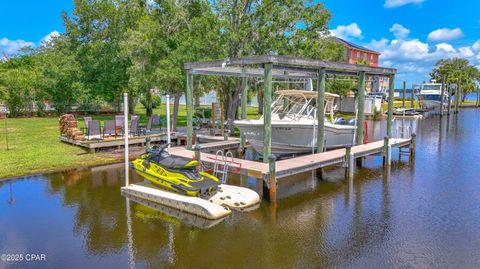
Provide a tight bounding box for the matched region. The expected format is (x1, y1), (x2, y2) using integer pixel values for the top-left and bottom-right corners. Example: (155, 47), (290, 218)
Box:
(60, 132), (177, 153)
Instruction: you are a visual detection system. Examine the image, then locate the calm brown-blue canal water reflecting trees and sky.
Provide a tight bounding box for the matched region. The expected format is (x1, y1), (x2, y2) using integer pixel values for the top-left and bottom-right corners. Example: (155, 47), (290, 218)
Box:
(0, 109), (480, 268)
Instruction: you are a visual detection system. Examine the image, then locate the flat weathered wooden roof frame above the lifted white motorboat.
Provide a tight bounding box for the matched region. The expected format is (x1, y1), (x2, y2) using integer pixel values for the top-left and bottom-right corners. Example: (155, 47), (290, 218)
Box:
(184, 55), (397, 79)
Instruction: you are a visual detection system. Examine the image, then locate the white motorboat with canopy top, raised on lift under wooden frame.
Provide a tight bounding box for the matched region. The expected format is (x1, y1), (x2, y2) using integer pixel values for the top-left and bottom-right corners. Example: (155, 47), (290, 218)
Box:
(234, 90), (356, 156)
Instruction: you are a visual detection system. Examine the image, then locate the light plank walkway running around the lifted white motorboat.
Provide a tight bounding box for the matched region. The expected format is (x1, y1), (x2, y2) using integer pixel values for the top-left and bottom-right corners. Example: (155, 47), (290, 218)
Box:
(170, 139), (411, 180)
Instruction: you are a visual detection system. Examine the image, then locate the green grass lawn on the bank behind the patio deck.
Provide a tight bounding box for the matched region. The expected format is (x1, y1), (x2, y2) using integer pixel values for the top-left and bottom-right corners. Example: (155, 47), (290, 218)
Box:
(0, 105), (259, 178)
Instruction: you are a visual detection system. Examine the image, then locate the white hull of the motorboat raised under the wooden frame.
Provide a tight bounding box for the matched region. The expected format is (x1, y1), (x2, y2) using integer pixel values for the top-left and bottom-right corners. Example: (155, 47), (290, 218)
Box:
(235, 120), (355, 155)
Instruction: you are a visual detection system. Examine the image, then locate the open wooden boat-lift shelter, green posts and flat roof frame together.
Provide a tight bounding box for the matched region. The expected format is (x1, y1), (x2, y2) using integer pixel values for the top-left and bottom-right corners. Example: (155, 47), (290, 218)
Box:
(184, 55), (397, 167)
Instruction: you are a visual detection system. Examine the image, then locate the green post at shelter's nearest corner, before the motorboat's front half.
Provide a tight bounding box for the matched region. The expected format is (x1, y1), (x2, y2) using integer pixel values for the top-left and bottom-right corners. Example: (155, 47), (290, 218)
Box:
(263, 63), (273, 163)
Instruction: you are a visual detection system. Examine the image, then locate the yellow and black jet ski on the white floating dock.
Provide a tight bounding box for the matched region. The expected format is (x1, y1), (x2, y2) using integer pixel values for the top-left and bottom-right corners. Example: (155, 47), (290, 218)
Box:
(131, 144), (220, 196)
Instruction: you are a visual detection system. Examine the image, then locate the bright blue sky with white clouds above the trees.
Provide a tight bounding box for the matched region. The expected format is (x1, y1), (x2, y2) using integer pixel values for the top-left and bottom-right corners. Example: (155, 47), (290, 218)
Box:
(0, 0), (480, 87)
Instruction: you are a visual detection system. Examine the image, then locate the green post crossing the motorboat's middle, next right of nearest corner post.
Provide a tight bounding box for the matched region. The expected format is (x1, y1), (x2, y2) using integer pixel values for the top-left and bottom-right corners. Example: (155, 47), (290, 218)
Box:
(317, 68), (327, 152)
